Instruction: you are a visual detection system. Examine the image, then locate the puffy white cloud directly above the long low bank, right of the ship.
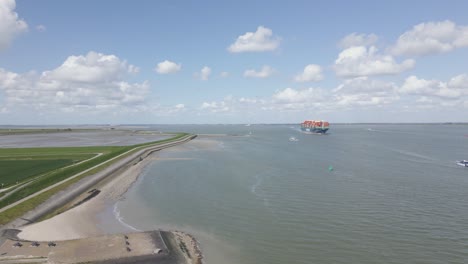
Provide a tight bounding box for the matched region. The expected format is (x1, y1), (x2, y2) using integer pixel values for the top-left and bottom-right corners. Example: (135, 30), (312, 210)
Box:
(334, 46), (415, 77)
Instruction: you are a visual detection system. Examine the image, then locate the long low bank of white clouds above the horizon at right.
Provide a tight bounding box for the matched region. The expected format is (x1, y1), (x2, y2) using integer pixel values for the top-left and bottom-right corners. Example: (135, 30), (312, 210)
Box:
(194, 71), (468, 118)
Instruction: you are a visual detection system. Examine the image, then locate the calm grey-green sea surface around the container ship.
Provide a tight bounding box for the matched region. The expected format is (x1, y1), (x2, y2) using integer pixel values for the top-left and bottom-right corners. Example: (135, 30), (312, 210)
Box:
(115, 125), (468, 264)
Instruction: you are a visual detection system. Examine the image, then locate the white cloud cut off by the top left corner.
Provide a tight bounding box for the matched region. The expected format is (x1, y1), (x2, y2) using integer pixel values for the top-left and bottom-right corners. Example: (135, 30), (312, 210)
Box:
(0, 0), (28, 51)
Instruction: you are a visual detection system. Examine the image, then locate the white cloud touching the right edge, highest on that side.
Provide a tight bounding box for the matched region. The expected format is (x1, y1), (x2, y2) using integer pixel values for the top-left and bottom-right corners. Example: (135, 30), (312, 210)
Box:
(391, 20), (468, 56)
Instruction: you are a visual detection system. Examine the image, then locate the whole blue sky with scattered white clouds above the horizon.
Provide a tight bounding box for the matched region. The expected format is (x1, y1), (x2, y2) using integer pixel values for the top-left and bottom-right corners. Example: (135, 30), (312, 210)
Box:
(0, 0), (468, 125)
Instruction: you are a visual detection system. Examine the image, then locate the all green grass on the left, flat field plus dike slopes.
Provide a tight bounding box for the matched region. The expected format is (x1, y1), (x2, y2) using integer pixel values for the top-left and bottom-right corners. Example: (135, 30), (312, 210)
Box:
(0, 133), (188, 225)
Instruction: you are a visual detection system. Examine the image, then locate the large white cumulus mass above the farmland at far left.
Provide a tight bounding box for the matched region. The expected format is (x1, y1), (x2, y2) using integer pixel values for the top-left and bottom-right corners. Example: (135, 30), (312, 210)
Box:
(0, 52), (149, 112)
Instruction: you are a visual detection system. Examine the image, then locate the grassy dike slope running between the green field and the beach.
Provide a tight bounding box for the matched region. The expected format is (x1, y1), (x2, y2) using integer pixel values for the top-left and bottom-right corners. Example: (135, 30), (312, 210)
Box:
(0, 133), (188, 225)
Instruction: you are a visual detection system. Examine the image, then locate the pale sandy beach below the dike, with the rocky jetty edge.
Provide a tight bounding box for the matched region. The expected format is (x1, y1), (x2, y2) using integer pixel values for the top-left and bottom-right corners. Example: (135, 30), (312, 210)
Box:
(0, 135), (203, 264)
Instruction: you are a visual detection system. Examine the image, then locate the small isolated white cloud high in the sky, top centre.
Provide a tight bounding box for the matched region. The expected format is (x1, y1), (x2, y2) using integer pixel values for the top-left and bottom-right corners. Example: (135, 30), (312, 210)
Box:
(228, 26), (280, 53)
